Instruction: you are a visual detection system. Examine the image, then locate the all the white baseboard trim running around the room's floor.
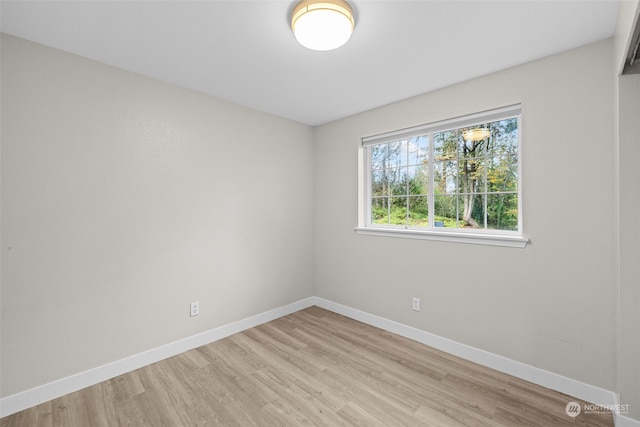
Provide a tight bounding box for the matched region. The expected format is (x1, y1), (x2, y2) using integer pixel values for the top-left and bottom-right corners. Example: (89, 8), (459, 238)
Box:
(0, 297), (640, 427)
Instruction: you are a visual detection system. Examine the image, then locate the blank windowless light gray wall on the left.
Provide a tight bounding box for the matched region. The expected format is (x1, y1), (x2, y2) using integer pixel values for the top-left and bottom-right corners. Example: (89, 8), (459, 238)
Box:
(0, 35), (313, 396)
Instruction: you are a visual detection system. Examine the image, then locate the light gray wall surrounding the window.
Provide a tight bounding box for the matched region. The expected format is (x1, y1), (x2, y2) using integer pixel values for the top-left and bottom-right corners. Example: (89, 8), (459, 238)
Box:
(314, 40), (616, 390)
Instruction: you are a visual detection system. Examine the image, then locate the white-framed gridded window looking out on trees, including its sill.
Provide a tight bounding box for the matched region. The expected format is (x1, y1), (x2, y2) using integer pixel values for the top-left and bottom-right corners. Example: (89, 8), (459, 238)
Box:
(357, 106), (527, 247)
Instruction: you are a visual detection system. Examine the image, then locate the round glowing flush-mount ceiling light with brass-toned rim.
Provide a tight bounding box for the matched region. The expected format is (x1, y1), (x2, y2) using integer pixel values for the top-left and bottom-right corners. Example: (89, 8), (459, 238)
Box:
(291, 0), (355, 50)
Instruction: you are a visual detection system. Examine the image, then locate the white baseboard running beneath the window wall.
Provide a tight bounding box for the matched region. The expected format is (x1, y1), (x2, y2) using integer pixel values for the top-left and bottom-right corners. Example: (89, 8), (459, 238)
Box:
(313, 297), (616, 412)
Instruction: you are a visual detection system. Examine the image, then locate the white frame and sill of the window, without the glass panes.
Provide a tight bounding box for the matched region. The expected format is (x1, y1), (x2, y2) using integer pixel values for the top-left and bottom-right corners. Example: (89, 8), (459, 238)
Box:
(355, 104), (529, 248)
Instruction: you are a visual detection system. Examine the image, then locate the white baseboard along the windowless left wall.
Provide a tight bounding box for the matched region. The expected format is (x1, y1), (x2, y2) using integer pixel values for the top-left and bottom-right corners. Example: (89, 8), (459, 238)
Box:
(0, 298), (313, 417)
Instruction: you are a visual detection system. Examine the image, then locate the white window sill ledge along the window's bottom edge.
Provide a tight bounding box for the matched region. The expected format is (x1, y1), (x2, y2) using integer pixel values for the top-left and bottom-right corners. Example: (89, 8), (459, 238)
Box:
(355, 227), (529, 248)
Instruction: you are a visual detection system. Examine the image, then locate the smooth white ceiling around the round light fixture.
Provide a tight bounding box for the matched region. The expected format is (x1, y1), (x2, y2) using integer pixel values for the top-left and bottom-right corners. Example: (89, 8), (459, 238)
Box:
(0, 0), (619, 125)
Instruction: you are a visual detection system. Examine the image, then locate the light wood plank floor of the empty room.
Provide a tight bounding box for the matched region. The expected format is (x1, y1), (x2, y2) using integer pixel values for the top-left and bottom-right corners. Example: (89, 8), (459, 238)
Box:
(0, 307), (613, 427)
